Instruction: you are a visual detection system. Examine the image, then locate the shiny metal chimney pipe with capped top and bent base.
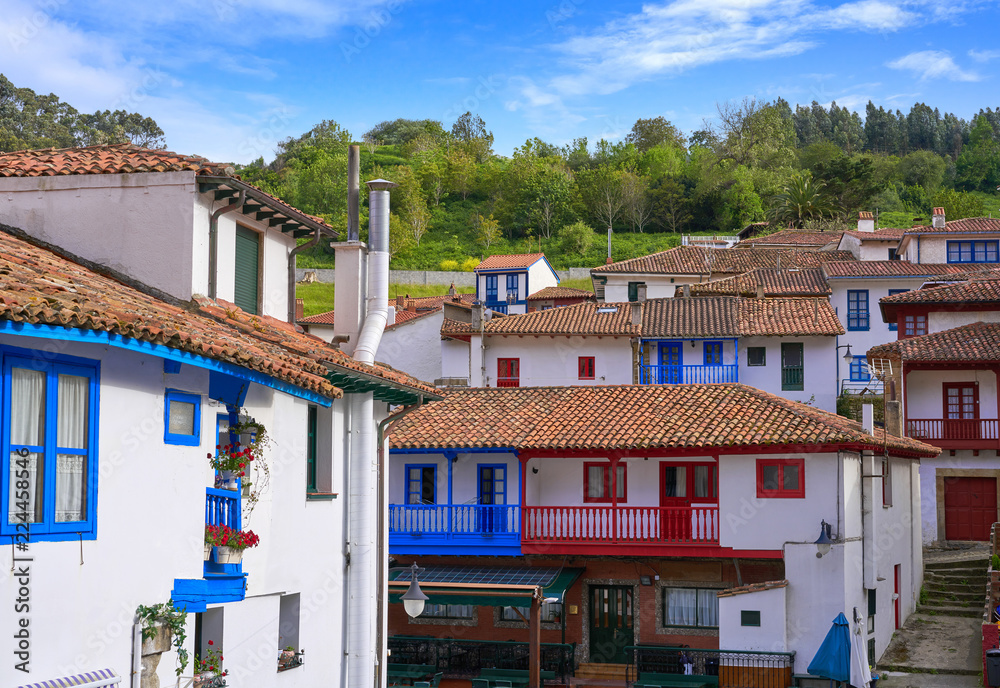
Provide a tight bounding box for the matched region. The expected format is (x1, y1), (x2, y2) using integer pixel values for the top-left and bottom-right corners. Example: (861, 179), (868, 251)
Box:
(354, 179), (398, 365)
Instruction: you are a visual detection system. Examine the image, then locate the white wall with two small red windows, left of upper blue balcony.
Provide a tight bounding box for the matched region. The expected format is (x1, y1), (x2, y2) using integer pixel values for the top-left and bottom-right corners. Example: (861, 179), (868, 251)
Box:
(486, 336), (632, 387)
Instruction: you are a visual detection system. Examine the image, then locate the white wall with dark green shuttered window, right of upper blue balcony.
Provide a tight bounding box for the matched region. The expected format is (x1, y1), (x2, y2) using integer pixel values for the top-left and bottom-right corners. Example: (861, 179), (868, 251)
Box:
(739, 337), (844, 411)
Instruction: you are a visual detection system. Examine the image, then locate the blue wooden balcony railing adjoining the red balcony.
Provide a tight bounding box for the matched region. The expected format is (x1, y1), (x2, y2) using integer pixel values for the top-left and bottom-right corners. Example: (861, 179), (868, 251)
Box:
(389, 504), (521, 555)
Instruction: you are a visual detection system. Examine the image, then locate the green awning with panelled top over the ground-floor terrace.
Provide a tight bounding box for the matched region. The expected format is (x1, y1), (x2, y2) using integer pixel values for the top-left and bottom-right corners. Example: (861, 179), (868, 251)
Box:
(389, 566), (583, 607)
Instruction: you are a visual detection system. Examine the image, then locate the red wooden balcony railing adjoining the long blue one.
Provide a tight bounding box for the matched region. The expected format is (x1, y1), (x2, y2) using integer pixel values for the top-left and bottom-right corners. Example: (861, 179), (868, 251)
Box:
(521, 506), (719, 554)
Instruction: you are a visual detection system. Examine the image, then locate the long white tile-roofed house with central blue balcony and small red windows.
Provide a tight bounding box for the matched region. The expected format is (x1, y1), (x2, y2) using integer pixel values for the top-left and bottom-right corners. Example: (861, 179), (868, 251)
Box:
(441, 296), (844, 411)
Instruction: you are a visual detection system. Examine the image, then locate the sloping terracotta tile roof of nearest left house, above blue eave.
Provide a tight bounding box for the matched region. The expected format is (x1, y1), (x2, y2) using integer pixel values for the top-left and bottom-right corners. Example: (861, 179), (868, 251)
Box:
(0, 226), (436, 397)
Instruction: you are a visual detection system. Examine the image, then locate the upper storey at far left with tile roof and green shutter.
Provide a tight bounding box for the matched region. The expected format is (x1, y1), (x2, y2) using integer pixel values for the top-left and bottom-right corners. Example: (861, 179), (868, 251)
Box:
(0, 144), (335, 321)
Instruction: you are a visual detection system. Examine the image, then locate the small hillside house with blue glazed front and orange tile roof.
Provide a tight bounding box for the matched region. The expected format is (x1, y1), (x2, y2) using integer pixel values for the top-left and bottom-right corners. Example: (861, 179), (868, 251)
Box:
(475, 253), (559, 313)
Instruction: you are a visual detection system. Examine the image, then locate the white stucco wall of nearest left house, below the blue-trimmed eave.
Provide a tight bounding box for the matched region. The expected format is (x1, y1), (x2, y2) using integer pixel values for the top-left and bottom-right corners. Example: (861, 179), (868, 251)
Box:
(0, 335), (345, 686)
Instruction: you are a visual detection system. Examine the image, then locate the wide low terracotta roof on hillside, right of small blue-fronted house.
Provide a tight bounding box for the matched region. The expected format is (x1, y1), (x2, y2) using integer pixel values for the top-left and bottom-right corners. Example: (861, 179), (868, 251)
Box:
(591, 246), (855, 275)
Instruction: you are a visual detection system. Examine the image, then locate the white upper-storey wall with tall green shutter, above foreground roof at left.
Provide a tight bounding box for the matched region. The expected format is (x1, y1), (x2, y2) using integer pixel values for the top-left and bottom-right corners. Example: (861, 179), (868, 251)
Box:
(0, 172), (295, 320)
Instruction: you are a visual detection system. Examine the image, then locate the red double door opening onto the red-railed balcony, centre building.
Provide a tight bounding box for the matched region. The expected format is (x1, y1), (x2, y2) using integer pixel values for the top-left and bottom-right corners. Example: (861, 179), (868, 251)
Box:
(660, 462), (719, 542)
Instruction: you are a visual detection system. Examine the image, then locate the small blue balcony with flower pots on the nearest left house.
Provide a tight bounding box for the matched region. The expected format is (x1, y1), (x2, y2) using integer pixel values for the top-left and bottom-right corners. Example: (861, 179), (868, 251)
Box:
(171, 487), (246, 612)
